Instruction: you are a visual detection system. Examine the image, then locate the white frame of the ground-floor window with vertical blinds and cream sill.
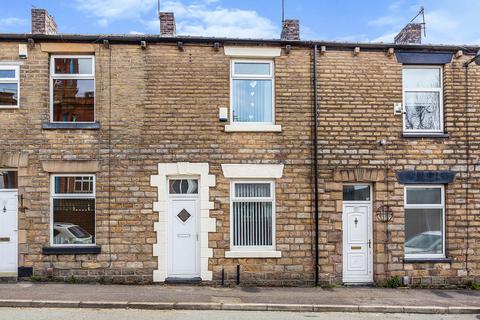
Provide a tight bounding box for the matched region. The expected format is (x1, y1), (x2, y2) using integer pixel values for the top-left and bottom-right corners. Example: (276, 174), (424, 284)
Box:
(230, 179), (276, 252)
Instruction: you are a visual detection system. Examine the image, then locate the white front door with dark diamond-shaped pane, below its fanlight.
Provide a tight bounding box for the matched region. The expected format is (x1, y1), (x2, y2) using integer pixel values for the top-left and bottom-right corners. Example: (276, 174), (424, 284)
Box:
(168, 195), (200, 278)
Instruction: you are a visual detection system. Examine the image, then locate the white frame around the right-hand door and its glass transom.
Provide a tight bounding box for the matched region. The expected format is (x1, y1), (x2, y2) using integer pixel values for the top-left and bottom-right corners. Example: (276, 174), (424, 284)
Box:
(342, 183), (374, 284)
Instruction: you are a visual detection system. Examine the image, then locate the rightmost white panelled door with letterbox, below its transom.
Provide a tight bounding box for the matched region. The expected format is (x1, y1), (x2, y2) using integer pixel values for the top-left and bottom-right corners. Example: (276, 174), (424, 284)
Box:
(342, 201), (373, 283)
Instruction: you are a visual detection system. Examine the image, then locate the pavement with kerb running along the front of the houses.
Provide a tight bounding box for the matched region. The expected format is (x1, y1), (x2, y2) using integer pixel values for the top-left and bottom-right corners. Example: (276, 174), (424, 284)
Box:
(0, 282), (480, 314)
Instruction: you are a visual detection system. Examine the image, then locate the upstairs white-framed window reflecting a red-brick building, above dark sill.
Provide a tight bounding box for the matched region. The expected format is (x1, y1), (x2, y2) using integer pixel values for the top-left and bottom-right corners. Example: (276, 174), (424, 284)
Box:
(50, 55), (95, 122)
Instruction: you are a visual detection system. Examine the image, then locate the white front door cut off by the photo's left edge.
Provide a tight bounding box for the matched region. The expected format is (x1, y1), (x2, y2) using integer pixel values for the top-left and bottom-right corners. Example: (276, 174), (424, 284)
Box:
(0, 191), (18, 277)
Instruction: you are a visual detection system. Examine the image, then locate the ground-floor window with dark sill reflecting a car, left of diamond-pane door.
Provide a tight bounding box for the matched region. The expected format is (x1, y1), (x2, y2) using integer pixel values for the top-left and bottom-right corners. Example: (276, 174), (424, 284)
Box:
(50, 174), (95, 246)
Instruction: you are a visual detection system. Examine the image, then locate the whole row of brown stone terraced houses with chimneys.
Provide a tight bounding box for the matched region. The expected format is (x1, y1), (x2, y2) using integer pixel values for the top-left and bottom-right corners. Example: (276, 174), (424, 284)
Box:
(0, 9), (480, 285)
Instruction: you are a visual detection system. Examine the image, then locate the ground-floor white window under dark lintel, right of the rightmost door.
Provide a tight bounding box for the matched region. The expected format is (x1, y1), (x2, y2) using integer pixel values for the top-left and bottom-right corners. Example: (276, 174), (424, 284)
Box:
(404, 185), (445, 259)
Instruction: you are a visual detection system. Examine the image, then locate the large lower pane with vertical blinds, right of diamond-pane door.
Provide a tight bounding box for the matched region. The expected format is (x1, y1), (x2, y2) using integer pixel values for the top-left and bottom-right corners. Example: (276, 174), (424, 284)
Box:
(233, 202), (273, 246)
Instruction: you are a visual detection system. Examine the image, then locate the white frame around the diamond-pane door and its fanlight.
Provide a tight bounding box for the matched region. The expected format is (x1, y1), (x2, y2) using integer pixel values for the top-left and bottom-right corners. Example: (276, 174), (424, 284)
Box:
(166, 175), (201, 279)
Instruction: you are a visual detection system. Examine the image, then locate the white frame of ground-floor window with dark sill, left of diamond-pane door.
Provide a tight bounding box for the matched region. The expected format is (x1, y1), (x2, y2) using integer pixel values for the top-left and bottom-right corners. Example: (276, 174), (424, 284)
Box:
(50, 173), (97, 247)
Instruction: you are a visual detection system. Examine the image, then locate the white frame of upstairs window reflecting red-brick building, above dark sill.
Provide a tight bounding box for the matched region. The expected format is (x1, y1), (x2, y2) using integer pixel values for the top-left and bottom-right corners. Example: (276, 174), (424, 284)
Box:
(50, 54), (97, 123)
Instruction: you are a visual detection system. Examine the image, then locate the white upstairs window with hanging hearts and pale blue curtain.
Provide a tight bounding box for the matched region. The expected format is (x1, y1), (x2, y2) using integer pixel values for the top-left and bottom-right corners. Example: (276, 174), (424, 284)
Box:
(230, 60), (275, 124)
